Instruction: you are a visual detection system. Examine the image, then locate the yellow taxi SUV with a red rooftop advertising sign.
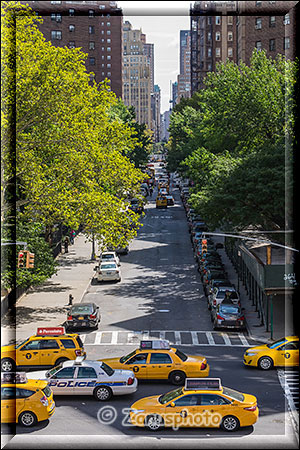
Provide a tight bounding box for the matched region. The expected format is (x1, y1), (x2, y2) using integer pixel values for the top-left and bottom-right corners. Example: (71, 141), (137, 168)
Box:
(1, 327), (86, 372)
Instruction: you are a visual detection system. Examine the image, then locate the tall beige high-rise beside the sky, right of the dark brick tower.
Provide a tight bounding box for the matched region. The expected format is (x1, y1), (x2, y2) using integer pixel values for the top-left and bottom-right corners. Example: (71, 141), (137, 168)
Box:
(123, 20), (152, 129)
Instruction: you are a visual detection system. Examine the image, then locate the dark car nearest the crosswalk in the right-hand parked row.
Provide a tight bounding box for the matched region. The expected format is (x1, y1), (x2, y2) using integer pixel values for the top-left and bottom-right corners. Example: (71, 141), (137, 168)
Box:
(212, 300), (245, 330)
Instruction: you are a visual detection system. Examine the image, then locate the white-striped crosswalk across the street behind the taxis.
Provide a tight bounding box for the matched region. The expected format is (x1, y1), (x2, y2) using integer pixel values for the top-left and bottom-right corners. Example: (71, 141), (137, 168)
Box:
(80, 330), (252, 347)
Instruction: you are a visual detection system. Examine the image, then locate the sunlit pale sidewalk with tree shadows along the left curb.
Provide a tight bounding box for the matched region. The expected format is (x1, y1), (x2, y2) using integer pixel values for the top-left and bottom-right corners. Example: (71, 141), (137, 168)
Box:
(1, 235), (95, 345)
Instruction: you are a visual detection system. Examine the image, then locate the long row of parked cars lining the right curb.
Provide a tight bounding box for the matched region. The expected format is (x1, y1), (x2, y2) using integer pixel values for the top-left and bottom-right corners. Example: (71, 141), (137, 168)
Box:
(177, 180), (245, 330)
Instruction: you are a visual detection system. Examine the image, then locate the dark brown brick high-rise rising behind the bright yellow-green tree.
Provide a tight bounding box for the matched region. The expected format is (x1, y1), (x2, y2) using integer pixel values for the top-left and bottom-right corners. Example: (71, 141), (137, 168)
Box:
(21, 1), (122, 97)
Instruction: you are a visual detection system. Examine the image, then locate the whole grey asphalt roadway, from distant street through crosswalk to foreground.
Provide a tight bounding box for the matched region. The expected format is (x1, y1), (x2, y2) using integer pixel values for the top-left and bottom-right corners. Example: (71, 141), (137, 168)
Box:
(2, 180), (297, 448)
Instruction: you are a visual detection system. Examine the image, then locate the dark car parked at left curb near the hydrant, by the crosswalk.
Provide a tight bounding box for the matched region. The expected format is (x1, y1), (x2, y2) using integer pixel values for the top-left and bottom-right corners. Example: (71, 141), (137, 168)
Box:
(65, 303), (101, 330)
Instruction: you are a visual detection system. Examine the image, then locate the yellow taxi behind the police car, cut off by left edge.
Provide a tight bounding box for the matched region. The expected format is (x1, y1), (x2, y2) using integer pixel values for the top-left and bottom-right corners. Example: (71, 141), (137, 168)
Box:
(1, 372), (55, 427)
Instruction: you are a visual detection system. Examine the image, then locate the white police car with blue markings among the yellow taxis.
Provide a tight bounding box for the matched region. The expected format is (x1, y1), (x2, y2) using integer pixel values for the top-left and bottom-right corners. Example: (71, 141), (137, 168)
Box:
(30, 357), (137, 401)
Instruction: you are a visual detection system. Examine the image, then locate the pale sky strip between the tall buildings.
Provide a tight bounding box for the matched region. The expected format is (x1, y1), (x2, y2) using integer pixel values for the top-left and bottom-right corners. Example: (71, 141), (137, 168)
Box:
(117, 1), (192, 113)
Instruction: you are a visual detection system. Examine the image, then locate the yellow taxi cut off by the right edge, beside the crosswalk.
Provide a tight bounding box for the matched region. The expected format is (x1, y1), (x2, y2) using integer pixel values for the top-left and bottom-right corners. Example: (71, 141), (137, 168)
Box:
(244, 336), (299, 370)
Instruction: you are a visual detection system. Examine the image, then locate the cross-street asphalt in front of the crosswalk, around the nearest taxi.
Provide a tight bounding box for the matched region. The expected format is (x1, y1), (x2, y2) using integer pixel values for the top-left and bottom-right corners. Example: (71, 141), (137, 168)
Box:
(11, 347), (286, 438)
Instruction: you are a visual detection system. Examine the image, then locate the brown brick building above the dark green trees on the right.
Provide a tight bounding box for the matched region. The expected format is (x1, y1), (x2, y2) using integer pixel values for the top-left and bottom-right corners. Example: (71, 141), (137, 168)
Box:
(190, 1), (298, 94)
